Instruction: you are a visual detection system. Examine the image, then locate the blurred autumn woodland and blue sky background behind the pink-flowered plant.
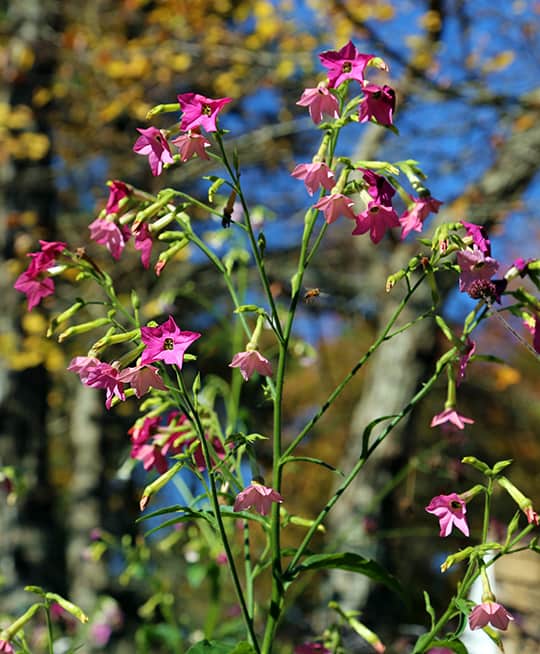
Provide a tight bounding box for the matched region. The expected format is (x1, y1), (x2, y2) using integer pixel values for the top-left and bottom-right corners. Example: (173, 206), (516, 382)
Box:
(0, 0), (540, 652)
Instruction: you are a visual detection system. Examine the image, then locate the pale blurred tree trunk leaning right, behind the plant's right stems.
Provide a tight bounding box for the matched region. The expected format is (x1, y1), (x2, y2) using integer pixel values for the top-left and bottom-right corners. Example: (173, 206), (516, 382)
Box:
(324, 89), (540, 624)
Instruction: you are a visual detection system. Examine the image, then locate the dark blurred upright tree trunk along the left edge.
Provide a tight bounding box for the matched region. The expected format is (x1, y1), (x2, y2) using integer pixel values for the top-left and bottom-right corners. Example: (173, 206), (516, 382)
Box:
(0, 0), (66, 611)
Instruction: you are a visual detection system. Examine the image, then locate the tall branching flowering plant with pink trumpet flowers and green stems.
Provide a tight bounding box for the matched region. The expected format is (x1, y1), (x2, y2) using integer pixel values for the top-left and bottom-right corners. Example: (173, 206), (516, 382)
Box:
(5, 42), (540, 654)
